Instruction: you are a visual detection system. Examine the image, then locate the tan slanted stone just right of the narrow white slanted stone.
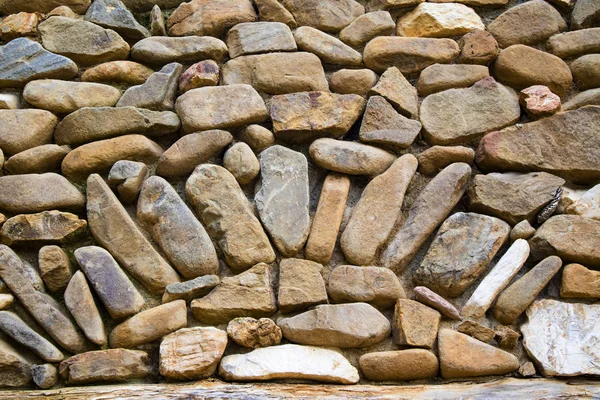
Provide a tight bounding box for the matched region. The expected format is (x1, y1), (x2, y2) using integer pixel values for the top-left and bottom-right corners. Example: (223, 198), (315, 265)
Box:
(492, 256), (564, 325)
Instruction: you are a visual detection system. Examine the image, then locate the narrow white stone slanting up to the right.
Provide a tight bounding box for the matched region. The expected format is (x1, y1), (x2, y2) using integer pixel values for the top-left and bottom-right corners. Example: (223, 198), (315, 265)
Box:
(460, 239), (529, 318)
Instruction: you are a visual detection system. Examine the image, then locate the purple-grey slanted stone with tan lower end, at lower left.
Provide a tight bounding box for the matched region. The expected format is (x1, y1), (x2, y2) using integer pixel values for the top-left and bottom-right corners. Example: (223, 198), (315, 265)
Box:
(75, 246), (146, 319)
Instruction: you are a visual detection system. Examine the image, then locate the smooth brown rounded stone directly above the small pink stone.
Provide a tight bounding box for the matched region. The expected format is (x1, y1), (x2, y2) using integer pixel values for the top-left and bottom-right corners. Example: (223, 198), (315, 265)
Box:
(494, 44), (573, 97)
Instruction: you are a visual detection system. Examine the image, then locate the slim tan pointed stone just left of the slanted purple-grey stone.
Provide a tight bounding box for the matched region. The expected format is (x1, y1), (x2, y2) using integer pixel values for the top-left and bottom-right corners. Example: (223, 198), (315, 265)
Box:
(64, 271), (112, 346)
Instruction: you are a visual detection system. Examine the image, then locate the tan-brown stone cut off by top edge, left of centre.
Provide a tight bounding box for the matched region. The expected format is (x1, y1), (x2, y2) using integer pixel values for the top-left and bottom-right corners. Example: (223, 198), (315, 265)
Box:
(167, 0), (258, 37)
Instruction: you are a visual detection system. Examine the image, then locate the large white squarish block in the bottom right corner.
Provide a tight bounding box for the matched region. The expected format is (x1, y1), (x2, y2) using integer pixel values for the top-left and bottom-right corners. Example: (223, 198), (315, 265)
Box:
(521, 299), (600, 377)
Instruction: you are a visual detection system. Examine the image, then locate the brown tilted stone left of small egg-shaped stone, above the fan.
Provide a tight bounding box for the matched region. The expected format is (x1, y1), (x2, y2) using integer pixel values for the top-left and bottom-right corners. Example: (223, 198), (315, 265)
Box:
(156, 129), (233, 178)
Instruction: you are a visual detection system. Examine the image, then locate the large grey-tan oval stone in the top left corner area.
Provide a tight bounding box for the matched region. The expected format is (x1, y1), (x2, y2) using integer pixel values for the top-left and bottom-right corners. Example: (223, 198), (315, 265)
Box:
(38, 17), (129, 65)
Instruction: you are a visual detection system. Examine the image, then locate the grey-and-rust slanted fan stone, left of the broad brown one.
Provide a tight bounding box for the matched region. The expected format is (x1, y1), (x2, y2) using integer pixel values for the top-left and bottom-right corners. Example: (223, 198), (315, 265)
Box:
(137, 176), (219, 279)
